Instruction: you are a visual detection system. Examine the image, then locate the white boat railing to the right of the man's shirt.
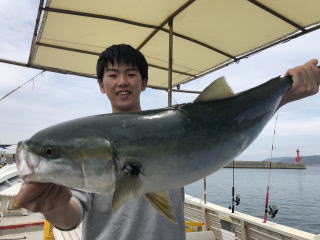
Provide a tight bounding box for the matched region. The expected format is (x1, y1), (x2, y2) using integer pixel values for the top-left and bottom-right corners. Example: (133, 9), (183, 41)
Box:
(184, 195), (320, 240)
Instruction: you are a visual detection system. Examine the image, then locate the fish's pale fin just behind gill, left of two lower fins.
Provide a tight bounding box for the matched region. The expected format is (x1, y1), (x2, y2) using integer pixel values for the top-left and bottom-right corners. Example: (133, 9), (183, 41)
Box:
(112, 175), (142, 212)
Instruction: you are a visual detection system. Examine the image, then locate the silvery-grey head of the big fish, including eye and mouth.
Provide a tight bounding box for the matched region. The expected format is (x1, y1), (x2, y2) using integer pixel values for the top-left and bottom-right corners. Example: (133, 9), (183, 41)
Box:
(16, 124), (115, 192)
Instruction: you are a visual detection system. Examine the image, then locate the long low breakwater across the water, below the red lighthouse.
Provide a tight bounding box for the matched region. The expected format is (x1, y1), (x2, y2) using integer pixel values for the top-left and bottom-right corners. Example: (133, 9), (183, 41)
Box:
(225, 161), (306, 169)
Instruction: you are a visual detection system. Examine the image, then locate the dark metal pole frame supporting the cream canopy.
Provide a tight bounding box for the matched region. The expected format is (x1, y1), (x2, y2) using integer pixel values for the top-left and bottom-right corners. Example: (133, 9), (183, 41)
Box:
(0, 0), (320, 94)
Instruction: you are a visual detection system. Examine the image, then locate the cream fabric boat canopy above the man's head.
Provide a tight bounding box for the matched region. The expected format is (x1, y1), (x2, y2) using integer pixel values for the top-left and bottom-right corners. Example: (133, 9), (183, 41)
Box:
(22, 0), (320, 90)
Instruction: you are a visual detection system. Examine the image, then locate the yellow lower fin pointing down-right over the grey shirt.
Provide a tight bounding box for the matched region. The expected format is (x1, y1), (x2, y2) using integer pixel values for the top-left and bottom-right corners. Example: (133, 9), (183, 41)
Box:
(144, 192), (177, 223)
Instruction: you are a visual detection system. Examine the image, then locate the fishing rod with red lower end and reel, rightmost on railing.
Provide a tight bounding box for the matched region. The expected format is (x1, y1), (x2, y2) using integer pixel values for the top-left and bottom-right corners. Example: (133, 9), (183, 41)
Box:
(263, 112), (279, 223)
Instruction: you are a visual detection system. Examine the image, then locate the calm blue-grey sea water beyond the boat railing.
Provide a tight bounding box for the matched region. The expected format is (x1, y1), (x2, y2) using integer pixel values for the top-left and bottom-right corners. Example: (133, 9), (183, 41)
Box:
(185, 165), (320, 234)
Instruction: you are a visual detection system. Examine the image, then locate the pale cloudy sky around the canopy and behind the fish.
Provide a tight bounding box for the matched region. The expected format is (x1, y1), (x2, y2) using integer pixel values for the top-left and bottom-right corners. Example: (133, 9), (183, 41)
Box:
(0, 0), (320, 161)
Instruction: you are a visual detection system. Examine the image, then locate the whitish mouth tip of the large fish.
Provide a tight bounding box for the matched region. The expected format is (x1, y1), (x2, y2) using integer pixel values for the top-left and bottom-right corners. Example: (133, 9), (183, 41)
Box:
(16, 141), (41, 180)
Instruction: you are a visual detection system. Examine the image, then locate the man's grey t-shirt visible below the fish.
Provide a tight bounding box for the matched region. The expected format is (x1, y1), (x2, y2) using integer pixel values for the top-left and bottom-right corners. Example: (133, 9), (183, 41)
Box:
(68, 188), (186, 240)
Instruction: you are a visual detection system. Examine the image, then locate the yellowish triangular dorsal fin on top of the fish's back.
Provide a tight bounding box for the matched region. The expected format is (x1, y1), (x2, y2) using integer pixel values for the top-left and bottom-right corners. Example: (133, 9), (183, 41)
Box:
(194, 77), (235, 102)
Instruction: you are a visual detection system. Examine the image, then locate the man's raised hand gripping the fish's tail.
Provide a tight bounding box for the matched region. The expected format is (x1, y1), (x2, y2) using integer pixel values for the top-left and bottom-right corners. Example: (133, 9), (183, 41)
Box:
(279, 59), (320, 107)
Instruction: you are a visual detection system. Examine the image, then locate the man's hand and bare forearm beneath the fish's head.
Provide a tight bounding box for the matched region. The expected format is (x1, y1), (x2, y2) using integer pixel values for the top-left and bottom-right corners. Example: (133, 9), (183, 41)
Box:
(16, 183), (81, 230)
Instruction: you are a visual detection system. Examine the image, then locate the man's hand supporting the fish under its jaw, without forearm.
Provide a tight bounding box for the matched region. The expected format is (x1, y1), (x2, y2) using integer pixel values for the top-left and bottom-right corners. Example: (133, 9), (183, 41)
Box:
(16, 183), (72, 213)
